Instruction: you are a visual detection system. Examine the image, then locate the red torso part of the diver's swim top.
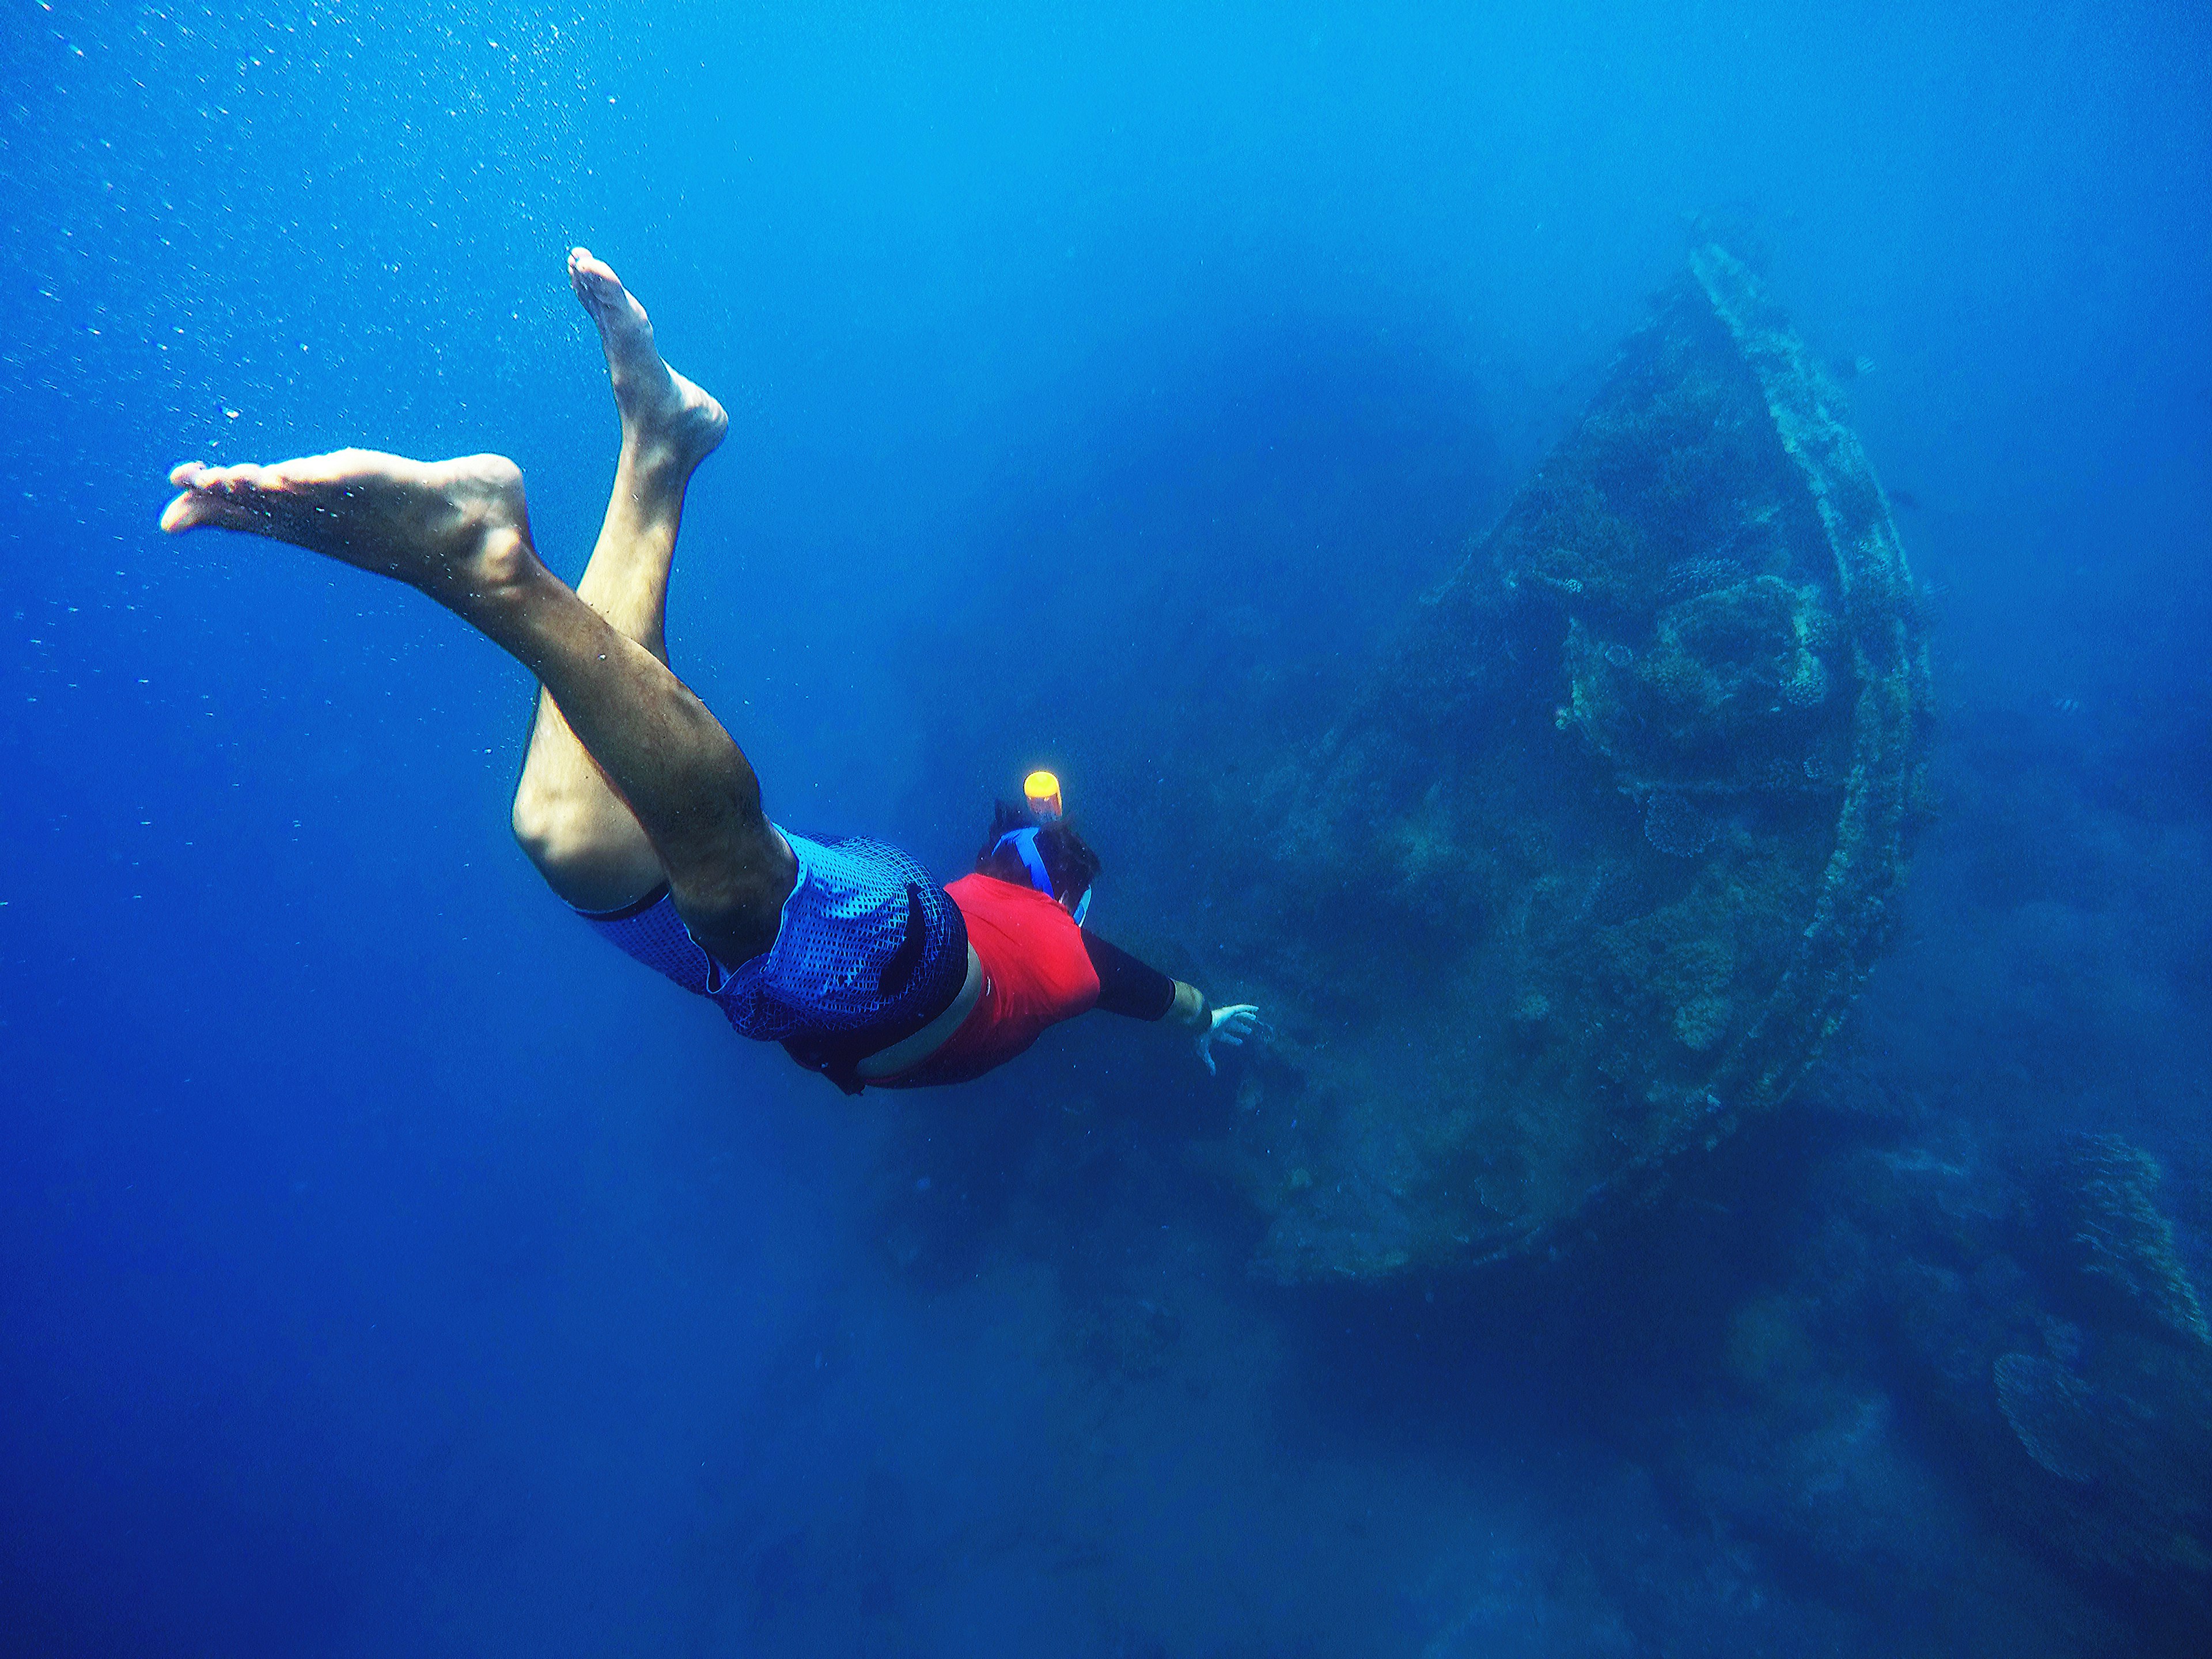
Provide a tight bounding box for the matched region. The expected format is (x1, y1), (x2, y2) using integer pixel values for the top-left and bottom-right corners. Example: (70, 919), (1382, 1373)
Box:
(898, 874), (1099, 1084)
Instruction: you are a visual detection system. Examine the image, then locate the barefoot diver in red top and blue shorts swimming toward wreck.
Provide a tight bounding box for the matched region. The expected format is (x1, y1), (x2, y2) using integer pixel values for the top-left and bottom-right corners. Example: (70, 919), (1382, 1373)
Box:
(161, 248), (1259, 1095)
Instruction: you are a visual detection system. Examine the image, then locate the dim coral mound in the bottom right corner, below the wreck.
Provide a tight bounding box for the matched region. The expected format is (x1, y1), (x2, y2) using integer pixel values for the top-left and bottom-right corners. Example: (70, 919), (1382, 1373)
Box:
(1876, 1135), (2212, 1628)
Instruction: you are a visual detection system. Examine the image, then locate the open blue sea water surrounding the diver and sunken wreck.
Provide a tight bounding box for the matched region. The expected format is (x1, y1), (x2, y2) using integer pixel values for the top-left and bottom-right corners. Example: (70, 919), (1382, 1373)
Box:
(0, 0), (2212, 1654)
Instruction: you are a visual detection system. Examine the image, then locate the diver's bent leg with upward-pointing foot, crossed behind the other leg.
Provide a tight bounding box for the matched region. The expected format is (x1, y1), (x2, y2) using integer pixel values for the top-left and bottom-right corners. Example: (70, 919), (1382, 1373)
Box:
(513, 248), (730, 911)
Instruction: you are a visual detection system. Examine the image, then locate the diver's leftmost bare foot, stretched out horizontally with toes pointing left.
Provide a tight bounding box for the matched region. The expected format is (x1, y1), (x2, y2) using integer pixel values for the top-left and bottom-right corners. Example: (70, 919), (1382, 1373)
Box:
(161, 449), (535, 606)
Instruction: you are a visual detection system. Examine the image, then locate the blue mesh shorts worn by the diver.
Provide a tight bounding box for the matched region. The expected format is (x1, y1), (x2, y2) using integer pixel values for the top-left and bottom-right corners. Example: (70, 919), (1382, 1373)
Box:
(577, 830), (967, 1077)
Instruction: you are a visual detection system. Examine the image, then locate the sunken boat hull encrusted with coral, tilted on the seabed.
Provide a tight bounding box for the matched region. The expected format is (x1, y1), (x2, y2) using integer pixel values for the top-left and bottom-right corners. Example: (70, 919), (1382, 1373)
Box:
(1225, 248), (1927, 1281)
